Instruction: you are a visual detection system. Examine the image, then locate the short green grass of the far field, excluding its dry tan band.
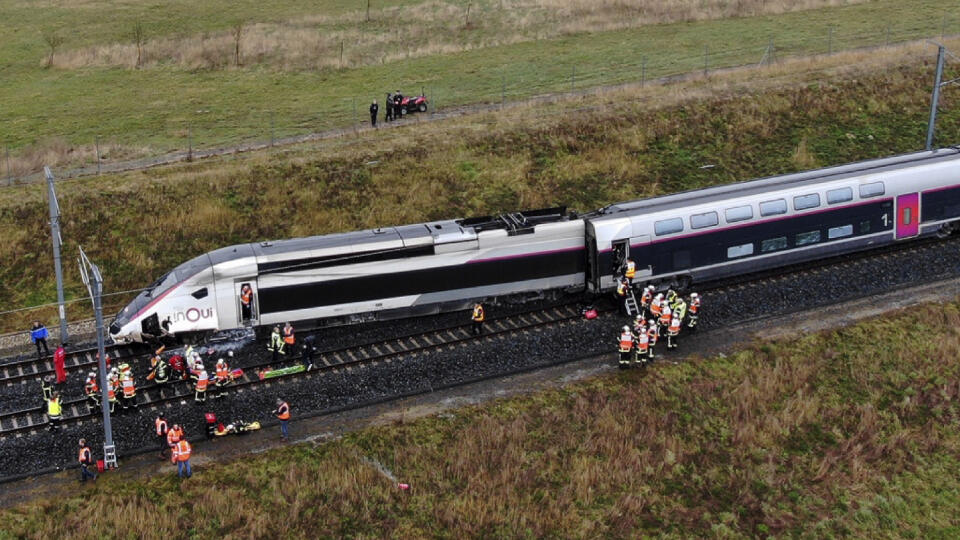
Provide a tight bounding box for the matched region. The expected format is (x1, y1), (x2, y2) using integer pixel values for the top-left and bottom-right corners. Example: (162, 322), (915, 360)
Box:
(0, 0), (960, 158)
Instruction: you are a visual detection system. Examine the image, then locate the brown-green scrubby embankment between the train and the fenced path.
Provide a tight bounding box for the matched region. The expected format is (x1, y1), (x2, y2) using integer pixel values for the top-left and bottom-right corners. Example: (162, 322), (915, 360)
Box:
(0, 37), (960, 331)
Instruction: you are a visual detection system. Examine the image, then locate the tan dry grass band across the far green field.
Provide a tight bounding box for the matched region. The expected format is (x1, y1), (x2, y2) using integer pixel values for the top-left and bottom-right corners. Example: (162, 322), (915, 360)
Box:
(44, 0), (864, 70)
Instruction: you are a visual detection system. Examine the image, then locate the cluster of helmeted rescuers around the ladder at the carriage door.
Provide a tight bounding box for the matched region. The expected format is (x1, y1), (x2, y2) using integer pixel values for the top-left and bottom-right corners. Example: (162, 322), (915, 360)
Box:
(616, 258), (701, 368)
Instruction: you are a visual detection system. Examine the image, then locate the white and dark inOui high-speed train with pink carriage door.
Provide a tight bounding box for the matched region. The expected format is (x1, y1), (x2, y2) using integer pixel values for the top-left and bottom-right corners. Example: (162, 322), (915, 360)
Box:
(110, 148), (960, 340)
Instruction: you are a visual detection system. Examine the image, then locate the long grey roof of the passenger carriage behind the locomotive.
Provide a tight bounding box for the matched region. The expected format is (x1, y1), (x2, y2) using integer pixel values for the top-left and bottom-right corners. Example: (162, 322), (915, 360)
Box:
(598, 147), (960, 217)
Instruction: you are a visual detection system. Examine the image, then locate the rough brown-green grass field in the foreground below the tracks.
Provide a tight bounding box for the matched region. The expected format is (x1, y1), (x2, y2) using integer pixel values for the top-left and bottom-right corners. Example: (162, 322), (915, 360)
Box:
(0, 303), (960, 538)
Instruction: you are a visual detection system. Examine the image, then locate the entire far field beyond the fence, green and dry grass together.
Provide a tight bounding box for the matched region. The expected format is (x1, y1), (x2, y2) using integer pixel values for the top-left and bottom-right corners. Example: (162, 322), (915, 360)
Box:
(0, 0), (960, 174)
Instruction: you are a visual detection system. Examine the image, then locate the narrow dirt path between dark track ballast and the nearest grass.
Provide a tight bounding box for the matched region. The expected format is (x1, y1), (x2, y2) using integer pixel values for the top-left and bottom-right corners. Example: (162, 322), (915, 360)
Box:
(0, 278), (960, 507)
